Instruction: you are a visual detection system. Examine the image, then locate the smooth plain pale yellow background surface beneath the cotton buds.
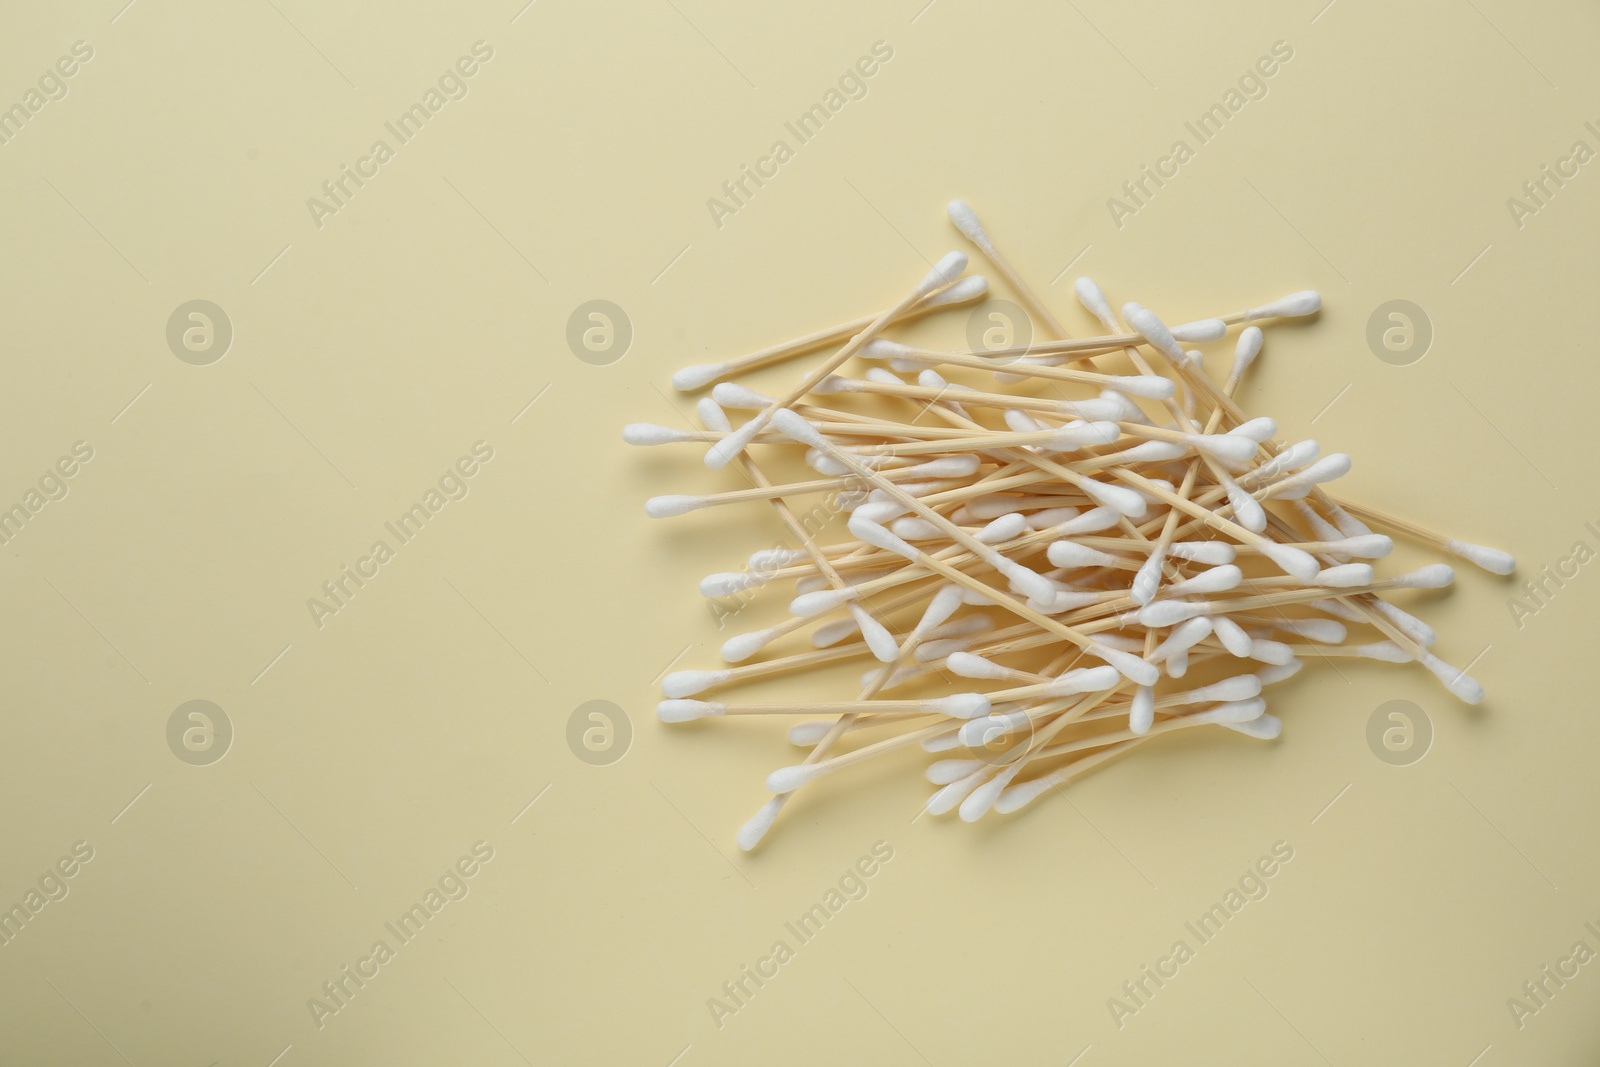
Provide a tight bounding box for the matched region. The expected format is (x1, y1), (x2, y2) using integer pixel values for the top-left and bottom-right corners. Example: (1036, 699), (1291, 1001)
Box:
(0, 0), (1600, 1067)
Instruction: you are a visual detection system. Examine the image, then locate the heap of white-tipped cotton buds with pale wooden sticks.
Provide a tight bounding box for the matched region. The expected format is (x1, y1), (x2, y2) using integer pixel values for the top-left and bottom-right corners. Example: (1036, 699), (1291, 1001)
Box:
(624, 202), (1515, 849)
